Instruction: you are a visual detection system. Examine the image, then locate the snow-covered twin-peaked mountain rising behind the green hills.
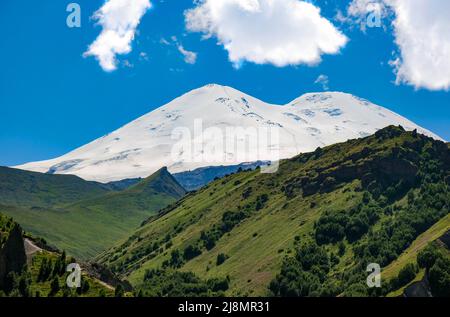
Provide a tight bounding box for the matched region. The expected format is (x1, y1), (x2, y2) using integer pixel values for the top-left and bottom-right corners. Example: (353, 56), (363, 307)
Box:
(17, 85), (440, 182)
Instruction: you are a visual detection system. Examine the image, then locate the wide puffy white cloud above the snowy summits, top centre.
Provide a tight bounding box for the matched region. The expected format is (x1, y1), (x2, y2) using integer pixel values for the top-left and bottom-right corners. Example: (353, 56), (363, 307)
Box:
(185, 0), (347, 67)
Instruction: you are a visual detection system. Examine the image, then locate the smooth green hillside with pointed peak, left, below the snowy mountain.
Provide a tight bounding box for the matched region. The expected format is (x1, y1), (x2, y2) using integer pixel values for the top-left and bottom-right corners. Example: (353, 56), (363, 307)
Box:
(0, 168), (185, 259)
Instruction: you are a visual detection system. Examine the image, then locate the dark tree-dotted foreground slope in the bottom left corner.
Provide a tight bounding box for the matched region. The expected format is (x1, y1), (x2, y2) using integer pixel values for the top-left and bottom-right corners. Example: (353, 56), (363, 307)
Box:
(0, 213), (114, 297)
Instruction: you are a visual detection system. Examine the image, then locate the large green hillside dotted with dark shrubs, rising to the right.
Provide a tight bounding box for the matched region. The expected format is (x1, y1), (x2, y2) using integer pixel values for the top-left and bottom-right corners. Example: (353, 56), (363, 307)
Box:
(97, 127), (450, 296)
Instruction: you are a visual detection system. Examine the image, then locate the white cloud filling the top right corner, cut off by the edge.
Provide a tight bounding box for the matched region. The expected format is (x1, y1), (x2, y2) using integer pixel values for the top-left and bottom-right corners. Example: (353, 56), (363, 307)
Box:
(348, 0), (450, 90)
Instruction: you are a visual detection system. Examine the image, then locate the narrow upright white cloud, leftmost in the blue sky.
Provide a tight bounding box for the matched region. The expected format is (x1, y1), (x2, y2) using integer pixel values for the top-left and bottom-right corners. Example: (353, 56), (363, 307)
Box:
(83, 0), (151, 71)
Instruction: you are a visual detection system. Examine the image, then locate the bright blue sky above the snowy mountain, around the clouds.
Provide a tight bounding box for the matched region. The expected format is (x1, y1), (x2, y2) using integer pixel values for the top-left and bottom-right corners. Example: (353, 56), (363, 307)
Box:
(0, 0), (450, 166)
